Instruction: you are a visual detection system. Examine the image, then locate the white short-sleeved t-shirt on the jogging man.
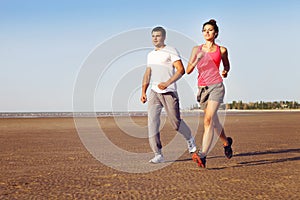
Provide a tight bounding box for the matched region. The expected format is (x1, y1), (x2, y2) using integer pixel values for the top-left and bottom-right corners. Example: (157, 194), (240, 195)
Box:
(147, 46), (181, 93)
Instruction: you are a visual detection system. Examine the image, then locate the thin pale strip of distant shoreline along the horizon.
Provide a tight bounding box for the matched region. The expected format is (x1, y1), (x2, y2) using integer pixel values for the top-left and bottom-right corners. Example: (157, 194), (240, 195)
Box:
(0, 109), (300, 119)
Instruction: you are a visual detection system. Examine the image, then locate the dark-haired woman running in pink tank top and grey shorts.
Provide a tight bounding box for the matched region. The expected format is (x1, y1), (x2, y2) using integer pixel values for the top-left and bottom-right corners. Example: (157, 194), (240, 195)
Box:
(186, 19), (233, 168)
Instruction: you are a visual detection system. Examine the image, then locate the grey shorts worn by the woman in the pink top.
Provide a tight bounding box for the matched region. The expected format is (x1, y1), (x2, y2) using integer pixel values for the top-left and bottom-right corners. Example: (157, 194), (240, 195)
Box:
(197, 82), (225, 109)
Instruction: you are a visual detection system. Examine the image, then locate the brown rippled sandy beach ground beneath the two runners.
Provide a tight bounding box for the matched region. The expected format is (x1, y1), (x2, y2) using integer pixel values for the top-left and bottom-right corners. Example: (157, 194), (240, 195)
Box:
(0, 112), (300, 199)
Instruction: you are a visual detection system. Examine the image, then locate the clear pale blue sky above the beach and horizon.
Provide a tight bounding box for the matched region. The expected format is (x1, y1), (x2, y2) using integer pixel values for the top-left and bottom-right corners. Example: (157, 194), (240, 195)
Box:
(0, 0), (300, 112)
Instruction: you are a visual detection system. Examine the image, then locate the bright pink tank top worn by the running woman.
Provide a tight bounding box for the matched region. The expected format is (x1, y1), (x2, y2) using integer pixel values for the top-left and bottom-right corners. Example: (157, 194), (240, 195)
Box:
(197, 45), (223, 86)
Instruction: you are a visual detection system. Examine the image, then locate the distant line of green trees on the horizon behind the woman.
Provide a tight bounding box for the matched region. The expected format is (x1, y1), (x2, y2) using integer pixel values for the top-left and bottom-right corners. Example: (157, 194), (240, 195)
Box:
(190, 101), (300, 110)
